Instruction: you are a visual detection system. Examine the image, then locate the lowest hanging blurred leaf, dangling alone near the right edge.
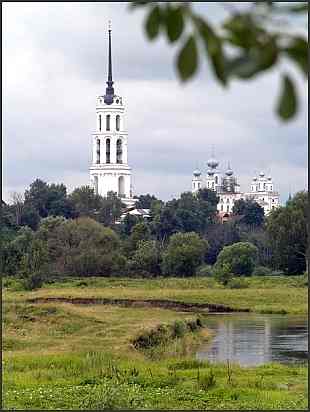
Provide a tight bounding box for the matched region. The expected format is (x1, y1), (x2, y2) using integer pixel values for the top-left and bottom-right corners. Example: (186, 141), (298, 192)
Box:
(277, 75), (298, 120)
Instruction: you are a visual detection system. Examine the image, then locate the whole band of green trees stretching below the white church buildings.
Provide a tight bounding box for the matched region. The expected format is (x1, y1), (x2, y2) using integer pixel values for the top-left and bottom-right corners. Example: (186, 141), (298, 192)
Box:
(0, 179), (309, 286)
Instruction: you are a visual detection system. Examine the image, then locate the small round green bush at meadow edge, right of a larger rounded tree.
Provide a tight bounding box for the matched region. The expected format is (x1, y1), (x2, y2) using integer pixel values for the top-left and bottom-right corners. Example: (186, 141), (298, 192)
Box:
(215, 242), (257, 276)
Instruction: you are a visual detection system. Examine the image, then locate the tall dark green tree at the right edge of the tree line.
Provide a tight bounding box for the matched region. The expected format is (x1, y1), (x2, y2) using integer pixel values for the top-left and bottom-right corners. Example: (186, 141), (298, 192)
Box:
(266, 192), (309, 274)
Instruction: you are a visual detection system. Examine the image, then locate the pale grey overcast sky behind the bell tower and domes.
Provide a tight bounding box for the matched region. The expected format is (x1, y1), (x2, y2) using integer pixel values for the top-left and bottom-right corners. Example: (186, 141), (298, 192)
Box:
(3, 2), (308, 202)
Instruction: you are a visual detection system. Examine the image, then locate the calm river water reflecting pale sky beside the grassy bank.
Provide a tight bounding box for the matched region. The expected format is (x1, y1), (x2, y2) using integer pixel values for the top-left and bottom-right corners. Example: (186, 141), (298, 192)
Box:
(196, 314), (308, 366)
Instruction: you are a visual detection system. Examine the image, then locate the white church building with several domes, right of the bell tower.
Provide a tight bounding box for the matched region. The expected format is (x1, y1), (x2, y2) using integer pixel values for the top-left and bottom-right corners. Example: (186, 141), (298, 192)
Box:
(192, 156), (280, 215)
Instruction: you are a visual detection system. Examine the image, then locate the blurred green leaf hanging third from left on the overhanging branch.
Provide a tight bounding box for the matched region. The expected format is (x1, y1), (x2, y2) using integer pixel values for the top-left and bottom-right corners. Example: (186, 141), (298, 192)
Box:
(177, 35), (198, 81)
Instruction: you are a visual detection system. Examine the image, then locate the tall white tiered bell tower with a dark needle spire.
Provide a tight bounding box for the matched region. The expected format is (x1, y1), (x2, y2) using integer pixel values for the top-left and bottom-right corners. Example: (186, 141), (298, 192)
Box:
(90, 27), (136, 206)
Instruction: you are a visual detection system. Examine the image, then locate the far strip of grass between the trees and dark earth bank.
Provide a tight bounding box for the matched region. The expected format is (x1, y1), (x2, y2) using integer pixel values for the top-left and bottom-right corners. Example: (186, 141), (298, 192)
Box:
(7, 276), (308, 314)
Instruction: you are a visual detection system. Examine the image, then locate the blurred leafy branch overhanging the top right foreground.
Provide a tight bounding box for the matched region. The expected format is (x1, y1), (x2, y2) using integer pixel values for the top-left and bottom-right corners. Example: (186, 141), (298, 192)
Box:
(130, 1), (308, 120)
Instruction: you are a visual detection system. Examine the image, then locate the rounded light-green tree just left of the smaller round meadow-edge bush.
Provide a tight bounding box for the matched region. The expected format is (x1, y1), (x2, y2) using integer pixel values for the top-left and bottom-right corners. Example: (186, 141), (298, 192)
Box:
(162, 232), (208, 276)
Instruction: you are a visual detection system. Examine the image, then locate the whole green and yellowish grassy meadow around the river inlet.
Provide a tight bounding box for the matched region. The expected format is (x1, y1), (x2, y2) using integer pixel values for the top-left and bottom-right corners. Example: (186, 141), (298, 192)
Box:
(3, 277), (307, 410)
